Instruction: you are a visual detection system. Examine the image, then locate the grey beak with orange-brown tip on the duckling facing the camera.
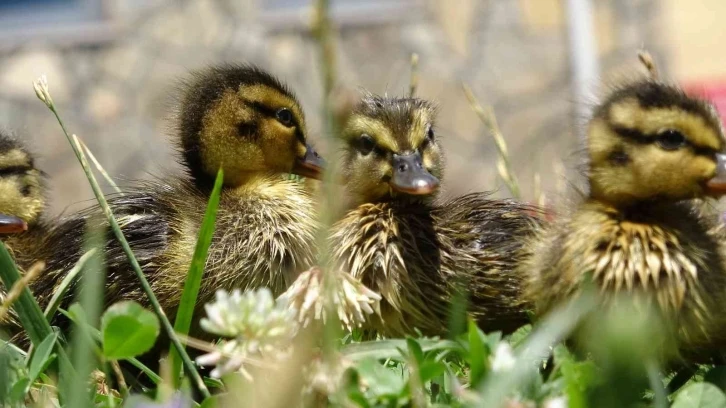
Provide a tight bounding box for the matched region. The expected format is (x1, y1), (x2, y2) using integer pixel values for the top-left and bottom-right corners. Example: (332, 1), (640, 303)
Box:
(390, 152), (439, 195)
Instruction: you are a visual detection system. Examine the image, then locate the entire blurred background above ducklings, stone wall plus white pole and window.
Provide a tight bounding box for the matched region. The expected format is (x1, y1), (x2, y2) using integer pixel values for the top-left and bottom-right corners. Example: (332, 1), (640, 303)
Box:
(0, 0), (726, 214)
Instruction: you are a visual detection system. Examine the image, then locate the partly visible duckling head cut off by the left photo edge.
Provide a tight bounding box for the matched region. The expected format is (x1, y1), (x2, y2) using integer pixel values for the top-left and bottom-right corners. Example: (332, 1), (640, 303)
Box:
(0, 133), (45, 233)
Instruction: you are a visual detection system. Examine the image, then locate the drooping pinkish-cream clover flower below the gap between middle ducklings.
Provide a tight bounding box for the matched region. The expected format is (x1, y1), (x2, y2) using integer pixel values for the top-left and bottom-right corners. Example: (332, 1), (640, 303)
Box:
(278, 267), (381, 330)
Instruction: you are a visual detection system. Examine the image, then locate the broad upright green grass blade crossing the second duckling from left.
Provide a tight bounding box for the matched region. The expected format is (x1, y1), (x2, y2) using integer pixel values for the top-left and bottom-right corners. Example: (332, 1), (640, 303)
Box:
(171, 169), (224, 386)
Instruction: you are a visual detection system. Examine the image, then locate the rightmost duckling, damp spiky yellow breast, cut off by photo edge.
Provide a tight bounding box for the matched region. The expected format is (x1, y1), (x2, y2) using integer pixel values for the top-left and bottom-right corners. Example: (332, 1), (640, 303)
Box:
(520, 79), (726, 351)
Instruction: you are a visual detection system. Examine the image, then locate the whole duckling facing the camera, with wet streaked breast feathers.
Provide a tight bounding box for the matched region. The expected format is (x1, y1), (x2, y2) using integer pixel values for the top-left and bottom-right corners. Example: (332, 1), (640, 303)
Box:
(331, 95), (544, 335)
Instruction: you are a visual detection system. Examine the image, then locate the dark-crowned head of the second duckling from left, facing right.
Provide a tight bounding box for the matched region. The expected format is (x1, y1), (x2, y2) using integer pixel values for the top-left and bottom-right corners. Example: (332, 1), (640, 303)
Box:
(178, 65), (322, 187)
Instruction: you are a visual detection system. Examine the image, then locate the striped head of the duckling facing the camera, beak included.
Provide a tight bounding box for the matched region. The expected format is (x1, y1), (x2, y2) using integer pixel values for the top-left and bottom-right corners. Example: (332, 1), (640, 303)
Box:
(342, 95), (443, 204)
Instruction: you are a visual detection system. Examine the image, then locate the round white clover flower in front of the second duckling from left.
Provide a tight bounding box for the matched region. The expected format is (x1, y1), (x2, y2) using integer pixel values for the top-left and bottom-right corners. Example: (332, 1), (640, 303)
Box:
(197, 288), (298, 378)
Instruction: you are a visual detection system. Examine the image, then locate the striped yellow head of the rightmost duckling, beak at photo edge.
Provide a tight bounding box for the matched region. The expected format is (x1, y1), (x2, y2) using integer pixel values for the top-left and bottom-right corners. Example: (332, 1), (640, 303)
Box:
(587, 80), (726, 206)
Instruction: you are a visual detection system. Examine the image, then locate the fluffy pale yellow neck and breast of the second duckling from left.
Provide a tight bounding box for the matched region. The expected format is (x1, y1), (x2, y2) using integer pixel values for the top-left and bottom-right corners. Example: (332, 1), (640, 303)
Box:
(191, 173), (318, 302)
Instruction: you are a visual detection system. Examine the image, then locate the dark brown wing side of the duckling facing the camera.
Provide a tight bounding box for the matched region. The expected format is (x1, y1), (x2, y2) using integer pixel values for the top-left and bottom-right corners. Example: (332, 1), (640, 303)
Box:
(435, 193), (541, 332)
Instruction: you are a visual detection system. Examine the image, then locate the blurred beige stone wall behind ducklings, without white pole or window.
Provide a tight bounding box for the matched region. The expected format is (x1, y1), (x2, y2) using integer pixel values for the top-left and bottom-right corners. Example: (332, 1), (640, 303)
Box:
(0, 0), (668, 214)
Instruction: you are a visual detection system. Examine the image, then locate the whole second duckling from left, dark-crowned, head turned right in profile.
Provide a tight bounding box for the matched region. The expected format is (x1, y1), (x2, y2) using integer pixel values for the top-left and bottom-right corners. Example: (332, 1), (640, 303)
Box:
(22, 65), (322, 333)
